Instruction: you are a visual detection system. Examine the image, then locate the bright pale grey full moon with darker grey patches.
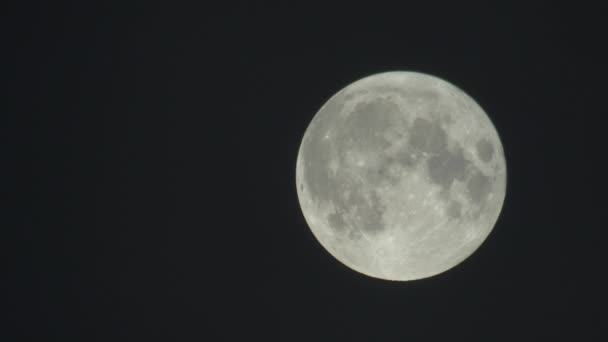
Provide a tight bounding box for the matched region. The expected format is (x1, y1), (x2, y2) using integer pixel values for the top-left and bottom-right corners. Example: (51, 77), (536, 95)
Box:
(296, 71), (507, 281)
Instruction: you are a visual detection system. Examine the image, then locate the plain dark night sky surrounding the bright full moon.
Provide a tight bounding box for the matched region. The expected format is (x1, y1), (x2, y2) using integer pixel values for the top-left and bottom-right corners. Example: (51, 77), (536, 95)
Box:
(0, 1), (608, 341)
